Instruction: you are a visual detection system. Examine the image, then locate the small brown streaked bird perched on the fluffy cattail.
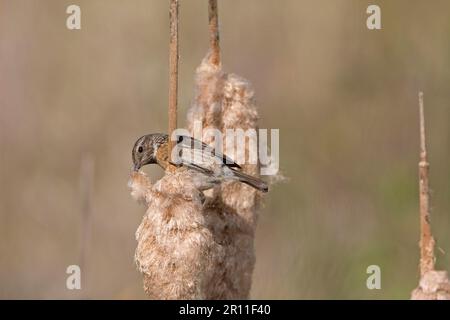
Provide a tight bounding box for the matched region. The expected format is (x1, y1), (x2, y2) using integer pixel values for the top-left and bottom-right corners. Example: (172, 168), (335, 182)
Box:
(132, 133), (269, 192)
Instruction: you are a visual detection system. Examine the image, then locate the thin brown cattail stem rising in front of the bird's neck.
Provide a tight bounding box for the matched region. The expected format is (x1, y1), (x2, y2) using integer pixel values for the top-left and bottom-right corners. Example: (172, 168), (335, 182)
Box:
(169, 0), (178, 171)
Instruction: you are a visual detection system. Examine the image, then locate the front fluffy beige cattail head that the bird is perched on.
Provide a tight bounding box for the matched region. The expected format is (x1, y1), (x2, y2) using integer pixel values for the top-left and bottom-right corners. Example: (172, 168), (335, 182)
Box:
(130, 170), (222, 299)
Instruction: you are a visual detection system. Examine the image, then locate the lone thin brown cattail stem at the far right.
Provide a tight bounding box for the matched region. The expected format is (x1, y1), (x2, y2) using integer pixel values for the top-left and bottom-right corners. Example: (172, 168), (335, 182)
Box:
(419, 92), (435, 276)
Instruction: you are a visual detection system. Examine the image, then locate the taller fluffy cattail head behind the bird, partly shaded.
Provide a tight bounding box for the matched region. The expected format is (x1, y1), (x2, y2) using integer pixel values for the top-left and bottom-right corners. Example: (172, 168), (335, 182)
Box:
(188, 54), (261, 299)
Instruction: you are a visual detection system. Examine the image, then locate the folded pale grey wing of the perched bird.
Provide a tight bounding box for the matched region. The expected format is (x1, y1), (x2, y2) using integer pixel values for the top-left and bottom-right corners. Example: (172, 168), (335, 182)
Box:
(177, 136), (241, 169)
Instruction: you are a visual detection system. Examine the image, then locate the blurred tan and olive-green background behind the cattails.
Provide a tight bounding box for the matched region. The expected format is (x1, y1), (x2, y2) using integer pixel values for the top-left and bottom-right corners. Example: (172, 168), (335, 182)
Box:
(0, 0), (450, 299)
